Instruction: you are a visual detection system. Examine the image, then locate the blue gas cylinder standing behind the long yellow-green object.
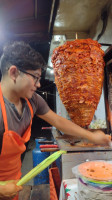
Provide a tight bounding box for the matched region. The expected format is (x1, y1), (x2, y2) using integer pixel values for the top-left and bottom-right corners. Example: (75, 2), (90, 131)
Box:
(32, 138), (50, 185)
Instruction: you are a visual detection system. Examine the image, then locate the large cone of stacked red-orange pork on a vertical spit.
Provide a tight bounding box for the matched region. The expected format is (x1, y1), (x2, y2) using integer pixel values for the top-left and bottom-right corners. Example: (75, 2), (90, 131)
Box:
(52, 39), (105, 127)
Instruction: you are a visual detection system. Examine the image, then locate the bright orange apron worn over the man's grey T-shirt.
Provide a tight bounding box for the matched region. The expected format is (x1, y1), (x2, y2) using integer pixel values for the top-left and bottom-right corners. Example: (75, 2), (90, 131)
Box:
(0, 86), (33, 200)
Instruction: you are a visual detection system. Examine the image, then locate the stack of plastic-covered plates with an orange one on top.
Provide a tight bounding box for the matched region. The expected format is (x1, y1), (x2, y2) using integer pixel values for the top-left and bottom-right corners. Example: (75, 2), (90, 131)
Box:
(72, 160), (112, 200)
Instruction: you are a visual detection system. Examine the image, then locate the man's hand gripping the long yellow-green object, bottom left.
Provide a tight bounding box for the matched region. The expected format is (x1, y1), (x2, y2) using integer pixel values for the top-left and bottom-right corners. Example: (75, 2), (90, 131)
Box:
(0, 181), (22, 200)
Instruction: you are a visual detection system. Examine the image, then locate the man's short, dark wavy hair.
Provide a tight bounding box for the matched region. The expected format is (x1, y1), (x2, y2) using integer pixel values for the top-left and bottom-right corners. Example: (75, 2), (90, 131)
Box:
(0, 41), (46, 75)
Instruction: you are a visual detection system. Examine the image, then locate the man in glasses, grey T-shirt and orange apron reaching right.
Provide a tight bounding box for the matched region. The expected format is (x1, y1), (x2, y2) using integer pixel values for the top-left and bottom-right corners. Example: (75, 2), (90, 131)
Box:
(0, 42), (110, 199)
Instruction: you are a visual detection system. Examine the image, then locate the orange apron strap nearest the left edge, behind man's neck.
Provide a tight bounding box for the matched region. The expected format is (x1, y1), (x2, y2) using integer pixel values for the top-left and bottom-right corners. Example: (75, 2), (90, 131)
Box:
(0, 85), (8, 131)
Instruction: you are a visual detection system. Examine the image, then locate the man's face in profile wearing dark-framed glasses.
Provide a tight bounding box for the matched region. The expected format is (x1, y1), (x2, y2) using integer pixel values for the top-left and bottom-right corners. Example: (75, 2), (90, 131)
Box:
(17, 69), (41, 99)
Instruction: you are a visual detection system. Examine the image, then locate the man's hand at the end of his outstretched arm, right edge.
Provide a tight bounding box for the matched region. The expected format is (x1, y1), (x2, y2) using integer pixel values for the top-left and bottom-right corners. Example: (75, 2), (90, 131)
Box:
(88, 130), (111, 145)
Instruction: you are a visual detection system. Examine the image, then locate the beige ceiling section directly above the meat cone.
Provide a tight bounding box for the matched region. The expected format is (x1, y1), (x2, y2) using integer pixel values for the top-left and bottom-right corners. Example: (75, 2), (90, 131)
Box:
(54, 0), (110, 39)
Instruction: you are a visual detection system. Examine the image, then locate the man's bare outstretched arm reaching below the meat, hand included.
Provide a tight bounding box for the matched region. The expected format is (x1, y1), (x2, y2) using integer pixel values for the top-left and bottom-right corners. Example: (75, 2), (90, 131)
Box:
(38, 110), (110, 145)
